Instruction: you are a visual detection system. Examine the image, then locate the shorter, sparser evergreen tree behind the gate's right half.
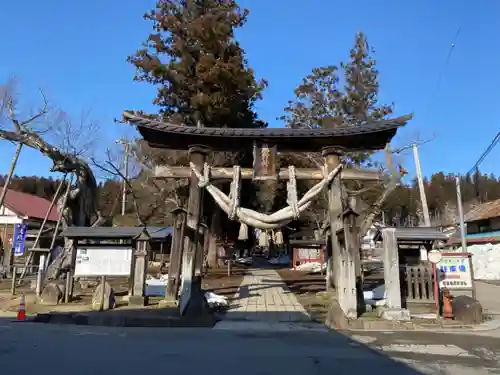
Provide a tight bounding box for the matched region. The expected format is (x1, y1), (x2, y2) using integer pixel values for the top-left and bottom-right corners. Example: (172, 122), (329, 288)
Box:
(281, 33), (393, 231)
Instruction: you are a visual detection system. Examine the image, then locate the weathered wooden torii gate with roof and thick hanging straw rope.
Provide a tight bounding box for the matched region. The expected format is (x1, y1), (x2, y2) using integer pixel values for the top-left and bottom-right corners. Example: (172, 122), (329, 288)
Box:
(124, 112), (411, 318)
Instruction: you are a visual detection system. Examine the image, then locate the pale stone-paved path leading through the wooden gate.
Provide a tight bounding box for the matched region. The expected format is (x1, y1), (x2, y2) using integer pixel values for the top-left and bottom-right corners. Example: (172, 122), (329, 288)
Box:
(215, 268), (327, 331)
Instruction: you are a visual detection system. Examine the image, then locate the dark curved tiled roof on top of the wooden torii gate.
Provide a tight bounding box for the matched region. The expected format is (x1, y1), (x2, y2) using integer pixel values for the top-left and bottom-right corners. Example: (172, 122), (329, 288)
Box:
(123, 111), (412, 152)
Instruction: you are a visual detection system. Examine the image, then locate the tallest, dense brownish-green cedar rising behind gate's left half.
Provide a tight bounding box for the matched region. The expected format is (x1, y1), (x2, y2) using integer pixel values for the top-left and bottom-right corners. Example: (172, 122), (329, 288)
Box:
(128, 0), (266, 128)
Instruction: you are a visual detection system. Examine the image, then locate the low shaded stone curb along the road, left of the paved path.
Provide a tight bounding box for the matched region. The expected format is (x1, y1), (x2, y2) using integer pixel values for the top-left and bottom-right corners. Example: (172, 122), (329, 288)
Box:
(31, 313), (216, 328)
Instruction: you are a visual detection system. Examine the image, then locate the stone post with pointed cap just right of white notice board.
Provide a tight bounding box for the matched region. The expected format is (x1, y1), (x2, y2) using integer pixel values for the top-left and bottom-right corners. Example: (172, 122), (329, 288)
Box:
(129, 228), (151, 306)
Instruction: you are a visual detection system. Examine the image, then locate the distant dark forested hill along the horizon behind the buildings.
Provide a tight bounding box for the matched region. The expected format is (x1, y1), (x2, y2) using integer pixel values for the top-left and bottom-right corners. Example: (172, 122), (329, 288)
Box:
(0, 172), (500, 226)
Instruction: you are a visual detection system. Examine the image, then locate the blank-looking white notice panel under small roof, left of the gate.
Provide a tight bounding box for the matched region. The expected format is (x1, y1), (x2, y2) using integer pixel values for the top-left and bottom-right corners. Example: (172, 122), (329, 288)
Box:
(75, 247), (132, 277)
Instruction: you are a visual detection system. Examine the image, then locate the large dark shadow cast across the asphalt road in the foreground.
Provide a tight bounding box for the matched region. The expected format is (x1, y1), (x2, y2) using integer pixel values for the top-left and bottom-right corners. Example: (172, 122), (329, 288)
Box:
(0, 313), (442, 375)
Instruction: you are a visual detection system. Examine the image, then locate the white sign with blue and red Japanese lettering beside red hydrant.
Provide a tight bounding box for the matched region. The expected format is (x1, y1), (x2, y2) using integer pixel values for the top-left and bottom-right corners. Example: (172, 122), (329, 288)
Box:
(436, 253), (473, 290)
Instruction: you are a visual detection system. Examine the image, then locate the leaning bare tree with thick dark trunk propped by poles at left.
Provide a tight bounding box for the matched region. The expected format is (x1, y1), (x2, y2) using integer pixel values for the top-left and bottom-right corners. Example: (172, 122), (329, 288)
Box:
(0, 78), (101, 276)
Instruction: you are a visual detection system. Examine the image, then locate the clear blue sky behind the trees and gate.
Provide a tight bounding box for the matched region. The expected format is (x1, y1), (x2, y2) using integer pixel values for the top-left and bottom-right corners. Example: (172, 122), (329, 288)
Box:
(0, 0), (500, 182)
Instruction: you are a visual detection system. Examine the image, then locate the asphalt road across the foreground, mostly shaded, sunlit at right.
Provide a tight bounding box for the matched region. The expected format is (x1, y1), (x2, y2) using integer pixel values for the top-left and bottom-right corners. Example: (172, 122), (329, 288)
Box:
(0, 320), (500, 375)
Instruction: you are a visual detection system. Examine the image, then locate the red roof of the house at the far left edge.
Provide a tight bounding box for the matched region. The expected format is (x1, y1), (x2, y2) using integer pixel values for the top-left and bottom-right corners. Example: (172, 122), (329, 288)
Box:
(0, 189), (59, 222)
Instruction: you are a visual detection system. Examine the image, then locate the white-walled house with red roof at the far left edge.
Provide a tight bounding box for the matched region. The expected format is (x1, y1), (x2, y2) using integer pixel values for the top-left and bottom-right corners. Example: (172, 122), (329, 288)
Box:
(0, 188), (59, 265)
